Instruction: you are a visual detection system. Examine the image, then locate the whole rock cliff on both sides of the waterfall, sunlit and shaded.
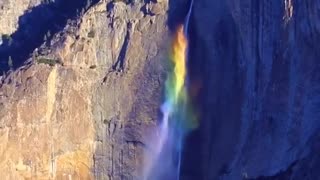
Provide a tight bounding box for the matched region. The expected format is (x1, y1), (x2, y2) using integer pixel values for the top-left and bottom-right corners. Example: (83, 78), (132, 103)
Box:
(0, 0), (320, 180)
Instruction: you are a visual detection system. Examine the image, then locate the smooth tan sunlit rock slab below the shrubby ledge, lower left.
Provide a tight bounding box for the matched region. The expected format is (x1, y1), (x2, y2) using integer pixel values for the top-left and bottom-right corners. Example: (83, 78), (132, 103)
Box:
(1, 60), (94, 179)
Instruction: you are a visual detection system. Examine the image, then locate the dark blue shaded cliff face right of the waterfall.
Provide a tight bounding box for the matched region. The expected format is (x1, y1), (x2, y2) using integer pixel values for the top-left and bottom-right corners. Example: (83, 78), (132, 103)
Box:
(184, 0), (320, 179)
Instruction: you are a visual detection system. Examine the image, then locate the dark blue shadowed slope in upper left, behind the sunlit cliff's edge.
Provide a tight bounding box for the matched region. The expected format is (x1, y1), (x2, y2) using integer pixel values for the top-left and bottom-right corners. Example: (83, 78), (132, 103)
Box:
(0, 0), (98, 74)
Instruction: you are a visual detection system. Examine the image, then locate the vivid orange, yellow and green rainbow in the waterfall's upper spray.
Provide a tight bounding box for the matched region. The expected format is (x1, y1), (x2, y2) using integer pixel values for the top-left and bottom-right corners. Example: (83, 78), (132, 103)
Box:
(162, 25), (198, 132)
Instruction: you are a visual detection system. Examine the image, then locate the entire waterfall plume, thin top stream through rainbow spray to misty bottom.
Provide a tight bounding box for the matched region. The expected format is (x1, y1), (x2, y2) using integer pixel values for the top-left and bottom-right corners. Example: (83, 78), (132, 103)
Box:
(143, 0), (198, 180)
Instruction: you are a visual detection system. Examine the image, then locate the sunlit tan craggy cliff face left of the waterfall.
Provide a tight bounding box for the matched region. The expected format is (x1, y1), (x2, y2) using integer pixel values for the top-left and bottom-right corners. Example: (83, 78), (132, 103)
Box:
(0, 1), (168, 179)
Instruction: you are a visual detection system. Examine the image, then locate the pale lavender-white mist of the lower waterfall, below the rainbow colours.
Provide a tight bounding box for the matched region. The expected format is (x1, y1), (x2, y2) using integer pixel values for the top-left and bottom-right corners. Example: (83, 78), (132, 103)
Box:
(143, 103), (180, 180)
